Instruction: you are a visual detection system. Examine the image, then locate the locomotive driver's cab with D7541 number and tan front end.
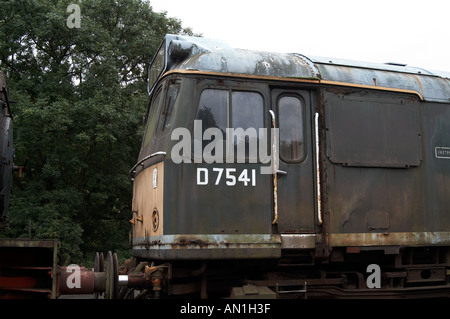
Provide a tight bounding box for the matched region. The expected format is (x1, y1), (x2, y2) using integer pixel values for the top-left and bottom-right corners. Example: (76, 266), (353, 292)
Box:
(132, 36), (317, 260)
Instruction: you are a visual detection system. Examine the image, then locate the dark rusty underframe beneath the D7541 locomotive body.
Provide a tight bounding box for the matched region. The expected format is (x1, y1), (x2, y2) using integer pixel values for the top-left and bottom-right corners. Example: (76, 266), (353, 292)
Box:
(124, 246), (450, 298)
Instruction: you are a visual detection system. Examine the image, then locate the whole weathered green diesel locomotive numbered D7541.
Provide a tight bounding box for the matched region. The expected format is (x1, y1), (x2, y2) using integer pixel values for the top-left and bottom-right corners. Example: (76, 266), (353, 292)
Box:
(0, 35), (450, 298)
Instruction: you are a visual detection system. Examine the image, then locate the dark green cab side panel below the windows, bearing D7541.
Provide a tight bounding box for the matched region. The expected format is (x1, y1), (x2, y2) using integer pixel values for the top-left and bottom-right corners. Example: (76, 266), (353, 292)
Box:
(164, 160), (273, 234)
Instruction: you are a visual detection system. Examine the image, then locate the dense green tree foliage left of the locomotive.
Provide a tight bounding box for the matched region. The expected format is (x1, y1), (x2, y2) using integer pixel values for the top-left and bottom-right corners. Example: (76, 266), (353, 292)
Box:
(0, 0), (192, 263)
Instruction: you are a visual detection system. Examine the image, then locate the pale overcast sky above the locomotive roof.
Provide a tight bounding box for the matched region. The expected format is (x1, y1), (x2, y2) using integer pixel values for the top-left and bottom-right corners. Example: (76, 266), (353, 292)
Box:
(150, 0), (450, 72)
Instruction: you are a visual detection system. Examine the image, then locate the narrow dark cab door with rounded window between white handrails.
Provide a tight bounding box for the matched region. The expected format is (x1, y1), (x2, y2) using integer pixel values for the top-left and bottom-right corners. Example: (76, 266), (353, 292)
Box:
(271, 89), (314, 234)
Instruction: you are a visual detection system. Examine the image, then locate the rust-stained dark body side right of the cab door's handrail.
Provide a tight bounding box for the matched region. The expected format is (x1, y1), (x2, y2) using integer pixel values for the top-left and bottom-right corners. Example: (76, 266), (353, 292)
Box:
(325, 89), (450, 246)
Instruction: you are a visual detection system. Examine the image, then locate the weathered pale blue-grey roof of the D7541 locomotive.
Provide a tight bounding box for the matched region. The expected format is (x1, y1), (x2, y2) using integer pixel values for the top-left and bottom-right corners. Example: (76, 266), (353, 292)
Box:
(149, 34), (450, 103)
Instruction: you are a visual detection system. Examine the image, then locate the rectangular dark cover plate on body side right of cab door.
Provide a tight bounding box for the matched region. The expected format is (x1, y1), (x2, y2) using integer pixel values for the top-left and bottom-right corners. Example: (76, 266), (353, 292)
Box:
(325, 89), (422, 167)
